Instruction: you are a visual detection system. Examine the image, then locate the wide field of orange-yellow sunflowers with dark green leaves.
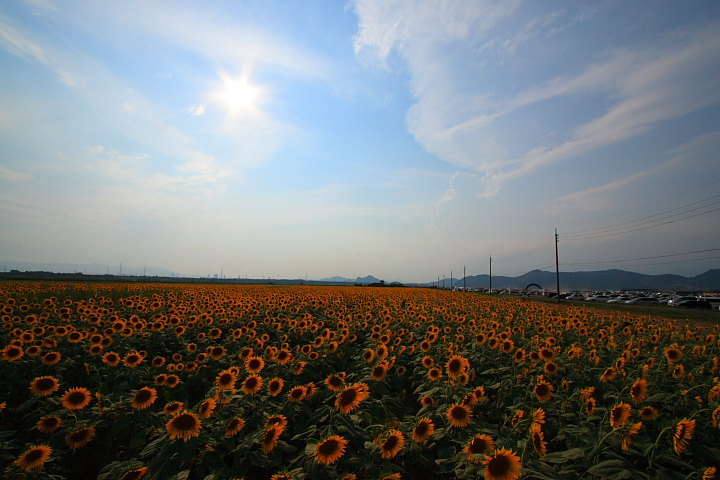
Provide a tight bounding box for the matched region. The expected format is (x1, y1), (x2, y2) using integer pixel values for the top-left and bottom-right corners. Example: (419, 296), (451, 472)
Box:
(0, 282), (720, 480)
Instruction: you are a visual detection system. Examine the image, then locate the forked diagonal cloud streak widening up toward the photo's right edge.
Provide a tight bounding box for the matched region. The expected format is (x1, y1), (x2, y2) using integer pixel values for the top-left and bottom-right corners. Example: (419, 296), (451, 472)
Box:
(487, 23), (720, 194)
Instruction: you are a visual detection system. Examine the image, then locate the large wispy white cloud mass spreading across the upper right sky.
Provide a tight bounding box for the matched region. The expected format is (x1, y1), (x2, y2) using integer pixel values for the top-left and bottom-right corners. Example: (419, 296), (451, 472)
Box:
(355, 0), (720, 195)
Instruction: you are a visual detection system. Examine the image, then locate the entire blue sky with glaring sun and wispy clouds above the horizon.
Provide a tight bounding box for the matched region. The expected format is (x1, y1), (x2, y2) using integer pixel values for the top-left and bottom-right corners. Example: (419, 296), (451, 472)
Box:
(0, 0), (720, 281)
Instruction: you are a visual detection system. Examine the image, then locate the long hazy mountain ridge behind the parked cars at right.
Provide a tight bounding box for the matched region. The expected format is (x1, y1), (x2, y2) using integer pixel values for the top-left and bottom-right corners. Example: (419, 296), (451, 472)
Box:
(453, 269), (720, 291)
